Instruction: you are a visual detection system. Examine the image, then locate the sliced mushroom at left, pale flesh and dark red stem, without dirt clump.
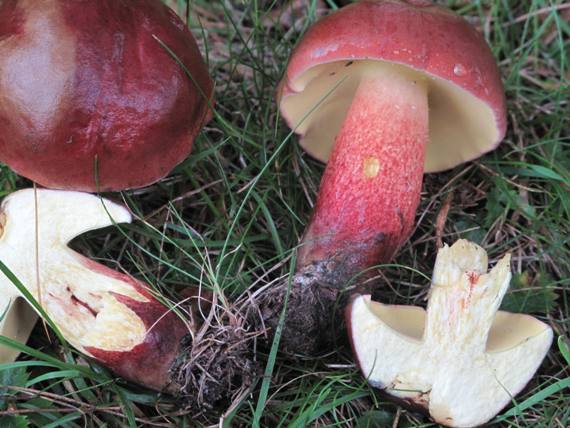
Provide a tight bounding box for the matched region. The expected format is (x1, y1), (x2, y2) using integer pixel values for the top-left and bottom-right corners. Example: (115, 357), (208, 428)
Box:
(0, 189), (188, 391)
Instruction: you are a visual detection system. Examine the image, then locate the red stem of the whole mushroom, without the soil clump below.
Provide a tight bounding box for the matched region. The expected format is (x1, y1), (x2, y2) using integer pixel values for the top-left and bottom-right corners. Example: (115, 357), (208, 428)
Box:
(297, 65), (428, 288)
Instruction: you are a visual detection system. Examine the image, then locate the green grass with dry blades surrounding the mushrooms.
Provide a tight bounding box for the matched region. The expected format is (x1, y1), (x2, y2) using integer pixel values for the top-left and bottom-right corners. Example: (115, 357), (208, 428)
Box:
(0, 0), (570, 427)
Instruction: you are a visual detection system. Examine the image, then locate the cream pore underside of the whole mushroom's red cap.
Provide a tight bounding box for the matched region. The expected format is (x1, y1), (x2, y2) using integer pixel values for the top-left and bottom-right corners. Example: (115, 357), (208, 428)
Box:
(281, 59), (500, 172)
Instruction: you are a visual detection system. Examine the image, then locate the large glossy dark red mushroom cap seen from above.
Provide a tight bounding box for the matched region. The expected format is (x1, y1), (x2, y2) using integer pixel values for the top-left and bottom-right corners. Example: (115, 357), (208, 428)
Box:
(0, 0), (213, 192)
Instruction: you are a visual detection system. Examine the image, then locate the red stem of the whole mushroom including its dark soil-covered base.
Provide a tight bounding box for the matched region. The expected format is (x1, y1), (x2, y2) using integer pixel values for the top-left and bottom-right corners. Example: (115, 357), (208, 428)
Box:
(261, 67), (428, 354)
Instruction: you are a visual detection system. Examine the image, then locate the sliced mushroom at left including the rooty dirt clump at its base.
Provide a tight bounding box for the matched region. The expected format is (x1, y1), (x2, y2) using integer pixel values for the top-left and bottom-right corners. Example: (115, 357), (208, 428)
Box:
(0, 189), (257, 412)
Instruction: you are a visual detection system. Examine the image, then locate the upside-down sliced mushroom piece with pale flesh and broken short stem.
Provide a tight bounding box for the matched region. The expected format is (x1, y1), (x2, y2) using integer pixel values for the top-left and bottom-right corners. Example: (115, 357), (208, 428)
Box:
(346, 240), (553, 427)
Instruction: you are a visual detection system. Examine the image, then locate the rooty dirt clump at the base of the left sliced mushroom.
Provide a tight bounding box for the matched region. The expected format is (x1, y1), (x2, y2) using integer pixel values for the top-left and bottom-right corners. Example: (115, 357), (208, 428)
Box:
(170, 300), (260, 417)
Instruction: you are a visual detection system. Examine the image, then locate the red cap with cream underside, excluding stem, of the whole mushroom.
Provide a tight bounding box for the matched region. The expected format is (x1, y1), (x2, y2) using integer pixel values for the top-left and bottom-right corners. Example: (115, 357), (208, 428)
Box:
(278, 0), (506, 172)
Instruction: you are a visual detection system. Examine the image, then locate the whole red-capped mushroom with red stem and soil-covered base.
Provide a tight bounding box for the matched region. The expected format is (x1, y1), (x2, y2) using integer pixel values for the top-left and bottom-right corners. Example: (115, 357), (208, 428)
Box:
(266, 0), (506, 352)
